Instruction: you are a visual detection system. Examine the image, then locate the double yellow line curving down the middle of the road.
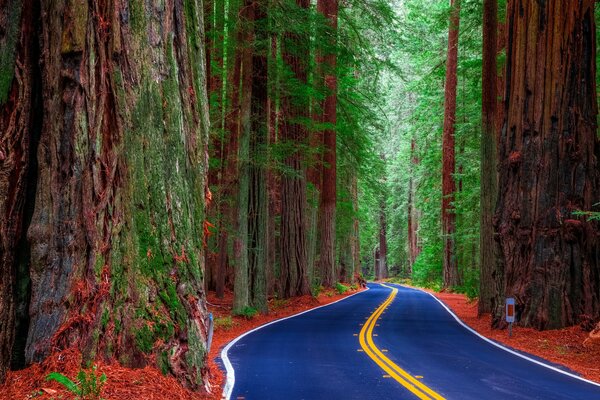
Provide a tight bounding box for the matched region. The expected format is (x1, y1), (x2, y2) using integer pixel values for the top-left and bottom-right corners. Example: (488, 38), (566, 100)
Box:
(359, 285), (444, 400)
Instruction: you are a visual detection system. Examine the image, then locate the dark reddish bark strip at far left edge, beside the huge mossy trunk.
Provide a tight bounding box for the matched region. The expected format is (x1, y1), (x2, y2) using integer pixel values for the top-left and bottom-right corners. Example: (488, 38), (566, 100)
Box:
(0, 1), (41, 382)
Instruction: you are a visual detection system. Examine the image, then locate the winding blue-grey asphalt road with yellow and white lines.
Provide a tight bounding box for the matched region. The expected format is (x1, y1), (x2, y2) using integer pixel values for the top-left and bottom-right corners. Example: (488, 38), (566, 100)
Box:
(221, 284), (600, 400)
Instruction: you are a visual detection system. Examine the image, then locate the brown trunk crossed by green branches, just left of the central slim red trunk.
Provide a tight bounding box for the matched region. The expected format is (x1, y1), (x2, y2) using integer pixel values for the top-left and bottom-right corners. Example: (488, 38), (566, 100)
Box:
(281, 0), (310, 297)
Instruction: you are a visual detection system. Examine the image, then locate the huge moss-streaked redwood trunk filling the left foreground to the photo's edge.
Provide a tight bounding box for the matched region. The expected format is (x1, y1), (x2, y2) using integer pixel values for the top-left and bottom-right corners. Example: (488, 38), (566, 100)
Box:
(0, 0), (208, 387)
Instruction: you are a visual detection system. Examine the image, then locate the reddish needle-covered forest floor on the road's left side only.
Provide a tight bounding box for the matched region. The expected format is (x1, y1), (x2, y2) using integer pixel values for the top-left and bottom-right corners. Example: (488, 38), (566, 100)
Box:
(0, 289), (357, 400)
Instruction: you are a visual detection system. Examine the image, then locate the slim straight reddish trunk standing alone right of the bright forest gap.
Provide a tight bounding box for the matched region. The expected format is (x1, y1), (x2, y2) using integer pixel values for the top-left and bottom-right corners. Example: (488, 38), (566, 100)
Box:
(442, 0), (460, 287)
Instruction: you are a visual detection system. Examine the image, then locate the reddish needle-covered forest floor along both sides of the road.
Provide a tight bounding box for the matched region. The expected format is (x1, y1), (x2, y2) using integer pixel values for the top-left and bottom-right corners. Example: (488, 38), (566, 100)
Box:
(0, 282), (600, 400)
